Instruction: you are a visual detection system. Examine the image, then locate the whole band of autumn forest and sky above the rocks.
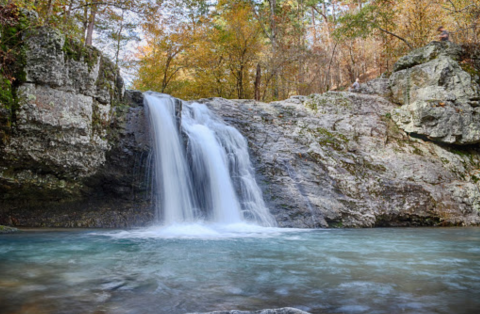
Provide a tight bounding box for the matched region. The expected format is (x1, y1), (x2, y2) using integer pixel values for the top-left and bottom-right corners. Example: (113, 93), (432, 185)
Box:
(0, 0), (480, 101)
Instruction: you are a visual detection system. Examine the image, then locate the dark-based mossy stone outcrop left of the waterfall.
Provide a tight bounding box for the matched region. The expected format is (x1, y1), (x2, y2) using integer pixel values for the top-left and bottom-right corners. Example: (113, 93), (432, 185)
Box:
(0, 22), (153, 227)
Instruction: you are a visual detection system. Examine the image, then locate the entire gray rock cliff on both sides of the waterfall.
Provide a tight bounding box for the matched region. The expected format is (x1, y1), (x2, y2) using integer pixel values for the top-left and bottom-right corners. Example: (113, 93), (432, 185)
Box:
(0, 15), (480, 228)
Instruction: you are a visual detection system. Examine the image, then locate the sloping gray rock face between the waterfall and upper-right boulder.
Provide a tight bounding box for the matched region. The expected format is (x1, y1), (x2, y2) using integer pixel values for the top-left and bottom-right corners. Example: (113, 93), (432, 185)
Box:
(202, 92), (480, 228)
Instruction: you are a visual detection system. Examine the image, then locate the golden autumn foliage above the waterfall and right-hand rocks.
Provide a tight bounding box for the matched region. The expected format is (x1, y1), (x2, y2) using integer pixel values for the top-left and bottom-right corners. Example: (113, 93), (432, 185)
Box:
(133, 0), (480, 100)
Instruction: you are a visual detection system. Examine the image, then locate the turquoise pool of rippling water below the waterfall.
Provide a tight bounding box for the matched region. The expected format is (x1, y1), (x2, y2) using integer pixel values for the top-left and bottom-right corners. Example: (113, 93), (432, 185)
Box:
(0, 225), (480, 314)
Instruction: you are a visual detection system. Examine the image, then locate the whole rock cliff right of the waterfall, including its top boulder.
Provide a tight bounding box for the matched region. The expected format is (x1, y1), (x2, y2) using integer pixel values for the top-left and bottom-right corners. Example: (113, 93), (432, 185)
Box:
(202, 43), (480, 228)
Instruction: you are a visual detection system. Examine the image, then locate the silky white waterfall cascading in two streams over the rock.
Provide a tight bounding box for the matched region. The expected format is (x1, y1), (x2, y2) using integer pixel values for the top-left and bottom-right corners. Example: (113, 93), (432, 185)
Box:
(144, 92), (275, 226)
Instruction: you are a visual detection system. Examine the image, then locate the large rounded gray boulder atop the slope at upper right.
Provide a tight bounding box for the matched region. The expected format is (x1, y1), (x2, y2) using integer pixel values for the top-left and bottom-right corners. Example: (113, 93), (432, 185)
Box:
(390, 42), (480, 145)
